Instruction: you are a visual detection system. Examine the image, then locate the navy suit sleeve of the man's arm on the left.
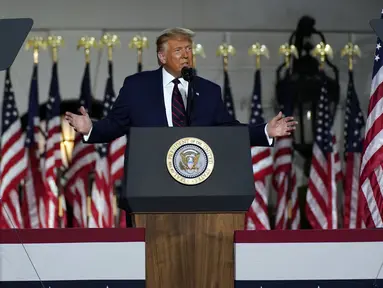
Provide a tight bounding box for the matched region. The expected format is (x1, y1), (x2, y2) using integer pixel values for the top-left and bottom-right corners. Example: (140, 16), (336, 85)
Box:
(84, 78), (131, 144)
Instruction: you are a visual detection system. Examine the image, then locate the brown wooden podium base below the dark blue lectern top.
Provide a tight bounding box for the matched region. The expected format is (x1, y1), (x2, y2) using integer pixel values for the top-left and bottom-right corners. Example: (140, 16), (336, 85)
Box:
(134, 213), (245, 288)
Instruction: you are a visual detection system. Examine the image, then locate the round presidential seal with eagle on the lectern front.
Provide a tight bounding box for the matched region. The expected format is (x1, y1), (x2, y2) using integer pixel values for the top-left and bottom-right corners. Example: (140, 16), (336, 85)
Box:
(166, 137), (214, 185)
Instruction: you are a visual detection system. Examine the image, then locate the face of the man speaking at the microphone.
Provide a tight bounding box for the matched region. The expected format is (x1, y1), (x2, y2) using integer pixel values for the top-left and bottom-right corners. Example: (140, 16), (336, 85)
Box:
(160, 38), (193, 77)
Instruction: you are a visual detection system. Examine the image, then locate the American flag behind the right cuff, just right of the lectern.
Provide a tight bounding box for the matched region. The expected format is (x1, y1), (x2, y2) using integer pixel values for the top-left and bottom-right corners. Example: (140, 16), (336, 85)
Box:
(245, 69), (273, 230)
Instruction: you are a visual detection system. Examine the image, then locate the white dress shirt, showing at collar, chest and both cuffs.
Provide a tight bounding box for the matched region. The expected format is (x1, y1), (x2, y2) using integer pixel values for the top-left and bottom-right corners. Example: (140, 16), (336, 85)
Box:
(83, 68), (273, 145)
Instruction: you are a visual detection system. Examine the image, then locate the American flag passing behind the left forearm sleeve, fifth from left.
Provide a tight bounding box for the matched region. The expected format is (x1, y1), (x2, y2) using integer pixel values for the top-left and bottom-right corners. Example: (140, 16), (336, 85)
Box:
(89, 61), (115, 228)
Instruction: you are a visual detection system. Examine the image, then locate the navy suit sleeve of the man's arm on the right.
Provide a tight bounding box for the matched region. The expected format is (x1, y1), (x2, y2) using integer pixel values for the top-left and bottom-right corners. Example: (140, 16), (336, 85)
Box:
(214, 85), (274, 147)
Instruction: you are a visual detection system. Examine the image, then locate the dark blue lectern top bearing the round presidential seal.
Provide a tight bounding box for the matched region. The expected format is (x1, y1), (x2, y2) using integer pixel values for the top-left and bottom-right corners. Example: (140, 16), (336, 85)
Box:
(119, 126), (255, 213)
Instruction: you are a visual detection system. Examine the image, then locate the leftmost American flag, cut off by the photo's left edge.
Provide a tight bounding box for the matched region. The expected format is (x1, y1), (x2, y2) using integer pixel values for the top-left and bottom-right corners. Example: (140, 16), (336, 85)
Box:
(0, 69), (27, 228)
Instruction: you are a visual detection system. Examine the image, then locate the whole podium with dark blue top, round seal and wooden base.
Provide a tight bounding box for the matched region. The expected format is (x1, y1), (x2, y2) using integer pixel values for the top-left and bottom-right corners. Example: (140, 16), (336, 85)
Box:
(119, 126), (254, 288)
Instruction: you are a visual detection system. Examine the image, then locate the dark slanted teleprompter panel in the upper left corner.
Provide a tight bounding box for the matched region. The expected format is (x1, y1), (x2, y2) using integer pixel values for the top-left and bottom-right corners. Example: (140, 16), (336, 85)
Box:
(0, 18), (33, 71)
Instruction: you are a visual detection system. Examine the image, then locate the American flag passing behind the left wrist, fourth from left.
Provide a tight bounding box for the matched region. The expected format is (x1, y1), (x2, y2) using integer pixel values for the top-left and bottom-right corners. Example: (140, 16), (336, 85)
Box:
(64, 62), (97, 228)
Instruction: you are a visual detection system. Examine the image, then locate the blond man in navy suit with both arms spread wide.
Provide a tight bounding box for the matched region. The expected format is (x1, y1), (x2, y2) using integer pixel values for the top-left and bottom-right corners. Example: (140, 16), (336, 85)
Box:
(65, 28), (297, 146)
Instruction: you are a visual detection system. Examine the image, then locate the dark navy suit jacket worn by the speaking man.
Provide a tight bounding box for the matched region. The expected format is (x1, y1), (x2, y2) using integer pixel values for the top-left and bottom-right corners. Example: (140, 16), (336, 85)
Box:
(84, 68), (274, 146)
